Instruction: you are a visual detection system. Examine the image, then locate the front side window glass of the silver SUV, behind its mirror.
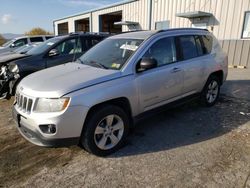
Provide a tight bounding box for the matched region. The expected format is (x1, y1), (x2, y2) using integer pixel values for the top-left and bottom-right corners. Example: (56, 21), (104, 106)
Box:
(143, 37), (176, 67)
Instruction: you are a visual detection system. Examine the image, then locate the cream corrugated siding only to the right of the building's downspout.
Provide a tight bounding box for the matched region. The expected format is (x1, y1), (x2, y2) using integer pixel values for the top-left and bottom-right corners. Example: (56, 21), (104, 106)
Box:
(151, 0), (250, 39)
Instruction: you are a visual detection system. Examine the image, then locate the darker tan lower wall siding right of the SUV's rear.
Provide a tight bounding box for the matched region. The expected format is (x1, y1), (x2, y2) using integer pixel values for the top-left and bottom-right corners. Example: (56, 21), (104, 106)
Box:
(220, 40), (250, 68)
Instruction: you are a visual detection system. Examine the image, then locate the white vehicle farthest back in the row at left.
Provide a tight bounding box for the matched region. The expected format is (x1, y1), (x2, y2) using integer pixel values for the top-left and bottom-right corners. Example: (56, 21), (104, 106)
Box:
(0, 35), (54, 55)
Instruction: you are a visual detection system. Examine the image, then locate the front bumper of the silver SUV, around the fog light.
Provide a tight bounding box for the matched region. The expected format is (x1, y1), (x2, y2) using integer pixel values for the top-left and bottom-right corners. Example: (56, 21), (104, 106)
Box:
(12, 105), (90, 147)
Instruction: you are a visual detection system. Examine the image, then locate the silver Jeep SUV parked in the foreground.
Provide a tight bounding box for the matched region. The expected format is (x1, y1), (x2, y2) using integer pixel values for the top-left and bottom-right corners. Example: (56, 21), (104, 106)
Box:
(13, 29), (228, 156)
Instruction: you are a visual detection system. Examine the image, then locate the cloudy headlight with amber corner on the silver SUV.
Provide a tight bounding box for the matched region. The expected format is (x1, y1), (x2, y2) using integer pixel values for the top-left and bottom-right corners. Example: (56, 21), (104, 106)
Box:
(34, 97), (70, 112)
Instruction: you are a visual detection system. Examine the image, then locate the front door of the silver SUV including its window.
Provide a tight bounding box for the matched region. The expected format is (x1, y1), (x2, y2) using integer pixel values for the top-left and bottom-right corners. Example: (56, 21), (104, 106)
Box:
(136, 37), (183, 111)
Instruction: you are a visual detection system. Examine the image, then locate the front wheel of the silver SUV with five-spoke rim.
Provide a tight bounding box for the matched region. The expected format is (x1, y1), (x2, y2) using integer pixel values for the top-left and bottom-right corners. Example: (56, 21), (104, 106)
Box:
(80, 105), (129, 156)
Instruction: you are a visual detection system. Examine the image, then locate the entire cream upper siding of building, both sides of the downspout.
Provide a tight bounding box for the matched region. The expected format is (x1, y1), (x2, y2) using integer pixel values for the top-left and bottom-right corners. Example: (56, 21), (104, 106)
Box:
(55, 0), (250, 40)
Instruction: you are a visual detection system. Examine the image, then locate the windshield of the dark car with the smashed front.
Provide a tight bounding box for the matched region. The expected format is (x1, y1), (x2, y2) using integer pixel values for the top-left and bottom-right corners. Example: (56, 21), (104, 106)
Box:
(27, 37), (62, 55)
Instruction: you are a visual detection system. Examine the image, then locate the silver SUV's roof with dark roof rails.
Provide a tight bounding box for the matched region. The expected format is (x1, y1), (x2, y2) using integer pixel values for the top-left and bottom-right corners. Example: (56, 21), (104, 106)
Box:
(111, 28), (208, 40)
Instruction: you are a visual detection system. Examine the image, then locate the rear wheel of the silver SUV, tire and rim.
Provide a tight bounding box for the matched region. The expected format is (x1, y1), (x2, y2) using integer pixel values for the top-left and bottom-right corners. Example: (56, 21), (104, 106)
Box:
(201, 75), (220, 107)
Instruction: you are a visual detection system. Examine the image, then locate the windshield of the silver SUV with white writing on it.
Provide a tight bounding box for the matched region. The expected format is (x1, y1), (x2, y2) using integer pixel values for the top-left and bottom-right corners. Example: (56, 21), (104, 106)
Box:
(80, 39), (143, 70)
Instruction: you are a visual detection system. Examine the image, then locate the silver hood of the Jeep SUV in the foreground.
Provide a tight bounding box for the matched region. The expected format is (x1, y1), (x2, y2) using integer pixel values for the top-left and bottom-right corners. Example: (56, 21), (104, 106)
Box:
(17, 63), (121, 98)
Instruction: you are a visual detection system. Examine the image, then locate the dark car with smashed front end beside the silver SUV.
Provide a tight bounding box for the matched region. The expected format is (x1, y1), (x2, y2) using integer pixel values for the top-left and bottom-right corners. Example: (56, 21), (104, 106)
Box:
(0, 33), (109, 99)
